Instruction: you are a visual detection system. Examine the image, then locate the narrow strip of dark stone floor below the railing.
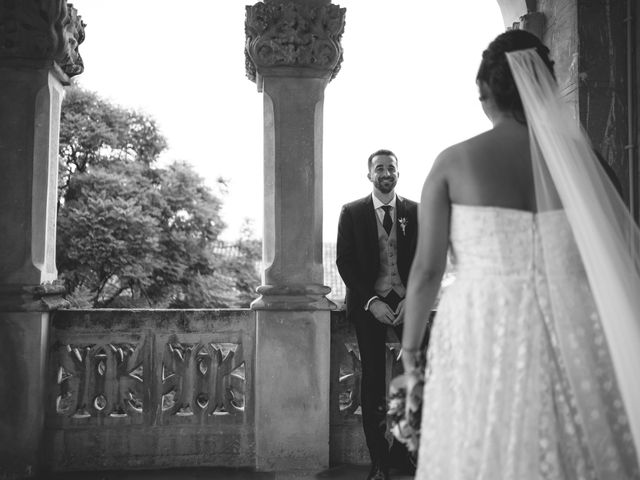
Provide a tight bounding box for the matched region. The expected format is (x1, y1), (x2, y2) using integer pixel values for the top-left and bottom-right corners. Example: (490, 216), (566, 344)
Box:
(44, 465), (413, 480)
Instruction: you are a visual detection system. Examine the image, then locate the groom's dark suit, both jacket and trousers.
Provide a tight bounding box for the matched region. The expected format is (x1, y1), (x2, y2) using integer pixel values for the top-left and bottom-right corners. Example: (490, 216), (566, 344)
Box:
(336, 195), (418, 465)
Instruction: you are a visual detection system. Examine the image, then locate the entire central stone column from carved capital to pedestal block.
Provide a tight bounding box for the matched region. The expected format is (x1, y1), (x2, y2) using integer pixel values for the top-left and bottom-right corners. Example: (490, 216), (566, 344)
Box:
(246, 0), (345, 471)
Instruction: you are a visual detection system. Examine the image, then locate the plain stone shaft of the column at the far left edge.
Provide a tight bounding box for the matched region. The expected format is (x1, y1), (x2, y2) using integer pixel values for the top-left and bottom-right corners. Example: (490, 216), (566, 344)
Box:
(0, 68), (64, 287)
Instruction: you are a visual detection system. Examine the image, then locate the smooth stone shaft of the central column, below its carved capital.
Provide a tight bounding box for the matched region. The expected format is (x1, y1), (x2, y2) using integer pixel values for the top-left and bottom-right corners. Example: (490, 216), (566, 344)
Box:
(264, 77), (326, 285)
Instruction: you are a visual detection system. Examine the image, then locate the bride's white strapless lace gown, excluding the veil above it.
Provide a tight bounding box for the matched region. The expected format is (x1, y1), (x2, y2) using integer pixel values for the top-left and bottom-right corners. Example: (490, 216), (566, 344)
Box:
(416, 205), (640, 480)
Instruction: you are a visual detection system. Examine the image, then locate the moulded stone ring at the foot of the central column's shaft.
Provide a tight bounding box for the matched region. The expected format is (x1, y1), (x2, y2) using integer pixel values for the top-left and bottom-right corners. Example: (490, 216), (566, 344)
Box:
(250, 284), (338, 311)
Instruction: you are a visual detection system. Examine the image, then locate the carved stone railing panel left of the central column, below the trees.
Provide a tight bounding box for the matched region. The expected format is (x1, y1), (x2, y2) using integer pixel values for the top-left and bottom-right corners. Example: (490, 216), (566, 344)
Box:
(46, 310), (255, 470)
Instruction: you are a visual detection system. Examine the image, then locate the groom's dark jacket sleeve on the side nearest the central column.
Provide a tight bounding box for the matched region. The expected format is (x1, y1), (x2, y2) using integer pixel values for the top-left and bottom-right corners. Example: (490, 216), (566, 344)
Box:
(336, 202), (376, 308)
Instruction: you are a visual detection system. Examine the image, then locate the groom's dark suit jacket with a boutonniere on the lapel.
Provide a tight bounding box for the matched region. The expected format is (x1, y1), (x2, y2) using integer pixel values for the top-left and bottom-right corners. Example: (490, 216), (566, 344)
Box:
(336, 195), (418, 321)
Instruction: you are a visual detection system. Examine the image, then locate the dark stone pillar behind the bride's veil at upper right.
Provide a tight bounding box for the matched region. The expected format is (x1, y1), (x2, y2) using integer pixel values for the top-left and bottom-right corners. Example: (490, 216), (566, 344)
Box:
(537, 0), (639, 205)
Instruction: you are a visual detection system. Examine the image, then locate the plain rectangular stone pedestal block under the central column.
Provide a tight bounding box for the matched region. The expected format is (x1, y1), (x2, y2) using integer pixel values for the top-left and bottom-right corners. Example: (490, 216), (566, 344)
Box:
(255, 311), (331, 470)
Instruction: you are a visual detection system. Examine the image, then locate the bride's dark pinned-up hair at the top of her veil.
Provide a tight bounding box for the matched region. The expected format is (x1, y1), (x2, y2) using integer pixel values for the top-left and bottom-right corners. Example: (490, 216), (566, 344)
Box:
(476, 30), (555, 123)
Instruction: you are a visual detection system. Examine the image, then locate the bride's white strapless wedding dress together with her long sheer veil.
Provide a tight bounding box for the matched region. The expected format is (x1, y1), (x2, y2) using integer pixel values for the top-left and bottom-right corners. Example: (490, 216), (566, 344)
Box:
(410, 50), (640, 480)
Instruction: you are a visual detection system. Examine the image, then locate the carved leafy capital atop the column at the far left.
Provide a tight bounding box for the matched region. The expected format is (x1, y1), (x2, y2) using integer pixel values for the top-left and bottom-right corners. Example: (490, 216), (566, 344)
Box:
(0, 0), (85, 77)
